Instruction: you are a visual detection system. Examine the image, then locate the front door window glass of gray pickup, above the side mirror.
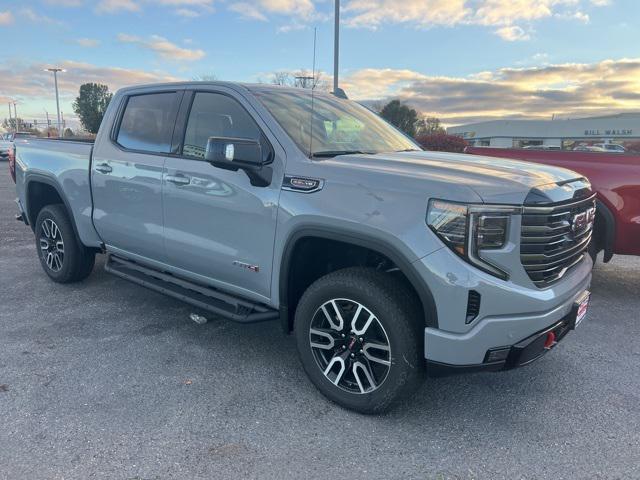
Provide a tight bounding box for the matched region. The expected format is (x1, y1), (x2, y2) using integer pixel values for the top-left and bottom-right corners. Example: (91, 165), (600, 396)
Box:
(183, 92), (260, 158)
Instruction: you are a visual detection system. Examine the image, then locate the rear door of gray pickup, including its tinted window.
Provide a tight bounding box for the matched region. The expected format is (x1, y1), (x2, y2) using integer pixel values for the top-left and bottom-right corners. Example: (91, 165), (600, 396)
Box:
(91, 91), (183, 262)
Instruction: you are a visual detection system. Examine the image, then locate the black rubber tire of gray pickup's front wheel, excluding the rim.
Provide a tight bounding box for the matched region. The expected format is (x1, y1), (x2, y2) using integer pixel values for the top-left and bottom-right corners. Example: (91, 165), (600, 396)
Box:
(295, 272), (422, 413)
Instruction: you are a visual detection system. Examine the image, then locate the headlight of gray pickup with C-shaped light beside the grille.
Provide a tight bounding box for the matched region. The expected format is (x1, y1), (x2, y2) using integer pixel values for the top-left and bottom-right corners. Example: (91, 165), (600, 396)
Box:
(427, 200), (520, 280)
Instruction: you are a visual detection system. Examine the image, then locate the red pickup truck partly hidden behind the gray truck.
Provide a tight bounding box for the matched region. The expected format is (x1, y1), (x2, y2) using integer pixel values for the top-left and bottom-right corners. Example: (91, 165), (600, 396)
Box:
(465, 147), (640, 262)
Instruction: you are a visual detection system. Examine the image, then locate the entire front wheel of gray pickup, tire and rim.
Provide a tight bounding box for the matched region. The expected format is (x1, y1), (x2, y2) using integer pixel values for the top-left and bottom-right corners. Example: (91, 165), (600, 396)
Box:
(294, 268), (424, 413)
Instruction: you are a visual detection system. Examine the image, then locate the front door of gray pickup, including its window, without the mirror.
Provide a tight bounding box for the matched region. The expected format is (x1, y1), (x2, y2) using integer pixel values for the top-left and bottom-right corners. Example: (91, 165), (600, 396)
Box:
(163, 91), (284, 300)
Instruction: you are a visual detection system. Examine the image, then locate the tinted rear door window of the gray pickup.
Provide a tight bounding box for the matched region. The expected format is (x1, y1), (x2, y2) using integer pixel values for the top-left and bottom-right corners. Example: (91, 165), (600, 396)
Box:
(117, 93), (177, 153)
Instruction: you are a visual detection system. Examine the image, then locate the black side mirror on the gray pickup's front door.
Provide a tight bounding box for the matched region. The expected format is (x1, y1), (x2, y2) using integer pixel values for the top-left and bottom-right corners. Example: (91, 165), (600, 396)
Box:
(204, 137), (273, 187)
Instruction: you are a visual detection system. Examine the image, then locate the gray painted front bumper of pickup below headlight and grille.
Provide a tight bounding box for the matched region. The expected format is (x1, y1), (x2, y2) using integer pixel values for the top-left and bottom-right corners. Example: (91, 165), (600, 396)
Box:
(418, 249), (592, 369)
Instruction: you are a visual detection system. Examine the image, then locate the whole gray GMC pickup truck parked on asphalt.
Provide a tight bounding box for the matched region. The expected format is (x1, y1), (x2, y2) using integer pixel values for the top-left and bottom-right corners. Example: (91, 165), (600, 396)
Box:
(15, 82), (594, 412)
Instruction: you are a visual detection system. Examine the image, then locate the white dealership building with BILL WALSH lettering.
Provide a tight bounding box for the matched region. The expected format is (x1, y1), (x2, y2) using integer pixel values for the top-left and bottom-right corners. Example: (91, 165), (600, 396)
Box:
(447, 112), (640, 148)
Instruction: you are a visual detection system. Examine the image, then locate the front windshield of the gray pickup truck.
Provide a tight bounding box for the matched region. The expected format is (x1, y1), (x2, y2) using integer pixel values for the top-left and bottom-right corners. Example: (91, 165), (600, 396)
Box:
(255, 89), (420, 157)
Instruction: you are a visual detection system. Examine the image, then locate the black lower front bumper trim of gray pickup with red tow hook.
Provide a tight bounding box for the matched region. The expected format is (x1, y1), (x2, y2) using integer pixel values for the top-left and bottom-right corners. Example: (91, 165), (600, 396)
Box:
(427, 307), (577, 376)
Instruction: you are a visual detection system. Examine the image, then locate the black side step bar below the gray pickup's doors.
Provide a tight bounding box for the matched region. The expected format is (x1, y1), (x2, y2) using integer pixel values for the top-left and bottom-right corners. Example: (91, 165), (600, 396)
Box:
(104, 254), (280, 323)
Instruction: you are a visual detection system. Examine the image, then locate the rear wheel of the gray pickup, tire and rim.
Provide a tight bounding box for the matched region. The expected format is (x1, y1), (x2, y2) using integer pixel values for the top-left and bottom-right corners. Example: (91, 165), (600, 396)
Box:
(35, 205), (95, 283)
